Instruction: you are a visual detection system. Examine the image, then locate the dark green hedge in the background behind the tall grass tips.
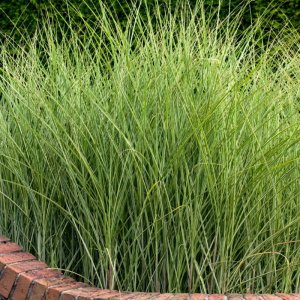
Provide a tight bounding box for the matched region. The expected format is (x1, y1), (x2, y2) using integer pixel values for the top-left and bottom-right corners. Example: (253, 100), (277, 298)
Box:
(0, 0), (300, 38)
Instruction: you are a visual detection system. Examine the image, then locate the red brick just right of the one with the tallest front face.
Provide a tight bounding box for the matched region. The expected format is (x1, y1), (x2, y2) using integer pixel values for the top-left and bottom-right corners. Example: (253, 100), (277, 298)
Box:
(11, 269), (62, 300)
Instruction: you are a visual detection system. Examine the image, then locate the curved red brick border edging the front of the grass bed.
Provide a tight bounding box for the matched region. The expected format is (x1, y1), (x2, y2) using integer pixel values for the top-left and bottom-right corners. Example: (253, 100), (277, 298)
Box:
(0, 236), (300, 300)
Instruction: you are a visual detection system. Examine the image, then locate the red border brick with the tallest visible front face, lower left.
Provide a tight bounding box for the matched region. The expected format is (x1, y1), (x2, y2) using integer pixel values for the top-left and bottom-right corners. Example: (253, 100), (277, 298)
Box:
(0, 261), (47, 298)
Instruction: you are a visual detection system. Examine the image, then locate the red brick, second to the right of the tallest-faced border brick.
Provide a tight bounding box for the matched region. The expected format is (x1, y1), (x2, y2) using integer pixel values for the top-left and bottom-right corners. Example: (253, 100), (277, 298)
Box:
(27, 276), (75, 300)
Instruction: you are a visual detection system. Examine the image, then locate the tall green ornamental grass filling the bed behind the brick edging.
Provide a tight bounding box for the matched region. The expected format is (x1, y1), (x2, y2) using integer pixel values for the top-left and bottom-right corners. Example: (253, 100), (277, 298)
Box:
(0, 1), (300, 292)
